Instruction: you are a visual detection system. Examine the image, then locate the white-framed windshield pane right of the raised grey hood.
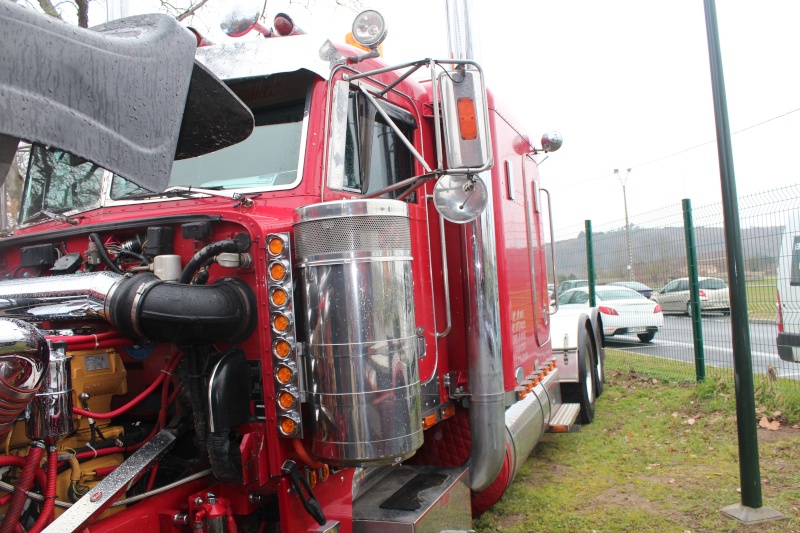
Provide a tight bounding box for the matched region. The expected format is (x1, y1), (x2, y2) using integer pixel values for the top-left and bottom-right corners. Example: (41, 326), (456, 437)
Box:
(111, 70), (312, 200)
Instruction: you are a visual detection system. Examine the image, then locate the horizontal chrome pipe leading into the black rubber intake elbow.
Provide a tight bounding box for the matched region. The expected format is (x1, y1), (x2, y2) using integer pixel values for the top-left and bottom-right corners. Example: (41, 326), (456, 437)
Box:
(0, 271), (122, 318)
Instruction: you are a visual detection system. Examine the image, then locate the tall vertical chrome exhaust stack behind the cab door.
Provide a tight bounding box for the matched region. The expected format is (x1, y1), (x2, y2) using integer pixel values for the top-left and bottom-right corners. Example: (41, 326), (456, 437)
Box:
(447, 0), (506, 492)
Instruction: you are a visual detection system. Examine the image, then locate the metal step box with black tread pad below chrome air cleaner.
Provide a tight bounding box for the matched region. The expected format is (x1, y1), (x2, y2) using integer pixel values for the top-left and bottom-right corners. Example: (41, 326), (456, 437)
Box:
(353, 465), (472, 533)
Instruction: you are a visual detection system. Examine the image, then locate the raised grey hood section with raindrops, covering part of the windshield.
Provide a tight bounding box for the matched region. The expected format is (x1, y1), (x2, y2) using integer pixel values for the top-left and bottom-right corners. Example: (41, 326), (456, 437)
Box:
(0, 2), (253, 192)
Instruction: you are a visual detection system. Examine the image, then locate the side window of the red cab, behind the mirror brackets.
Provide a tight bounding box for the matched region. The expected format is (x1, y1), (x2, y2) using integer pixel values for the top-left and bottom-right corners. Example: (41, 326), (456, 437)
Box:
(344, 91), (416, 201)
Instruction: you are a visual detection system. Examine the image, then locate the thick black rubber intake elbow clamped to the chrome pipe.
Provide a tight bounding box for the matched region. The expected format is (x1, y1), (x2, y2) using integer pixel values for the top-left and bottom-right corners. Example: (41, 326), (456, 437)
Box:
(105, 274), (257, 344)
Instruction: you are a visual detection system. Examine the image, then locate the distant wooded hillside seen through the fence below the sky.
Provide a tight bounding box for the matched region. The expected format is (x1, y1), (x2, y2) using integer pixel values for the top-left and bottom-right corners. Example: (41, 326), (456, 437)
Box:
(547, 226), (783, 287)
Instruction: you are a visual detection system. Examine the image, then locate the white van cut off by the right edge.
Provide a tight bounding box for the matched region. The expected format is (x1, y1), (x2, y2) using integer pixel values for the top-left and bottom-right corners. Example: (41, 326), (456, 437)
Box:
(776, 212), (800, 363)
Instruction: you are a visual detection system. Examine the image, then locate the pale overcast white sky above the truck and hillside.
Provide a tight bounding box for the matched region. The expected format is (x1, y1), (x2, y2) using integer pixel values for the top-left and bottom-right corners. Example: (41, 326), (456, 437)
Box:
(101, 0), (800, 233)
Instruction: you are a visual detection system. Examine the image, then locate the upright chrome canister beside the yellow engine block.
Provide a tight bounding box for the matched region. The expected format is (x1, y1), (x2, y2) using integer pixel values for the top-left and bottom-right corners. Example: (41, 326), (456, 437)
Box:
(25, 342), (75, 439)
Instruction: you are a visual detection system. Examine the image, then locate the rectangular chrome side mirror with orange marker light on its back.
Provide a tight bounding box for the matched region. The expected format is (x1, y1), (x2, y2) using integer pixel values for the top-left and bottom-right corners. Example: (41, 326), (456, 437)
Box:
(439, 68), (493, 170)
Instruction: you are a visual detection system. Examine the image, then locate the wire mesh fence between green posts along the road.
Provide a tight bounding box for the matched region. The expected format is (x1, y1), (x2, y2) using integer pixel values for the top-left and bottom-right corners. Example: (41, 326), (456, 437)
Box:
(548, 184), (800, 389)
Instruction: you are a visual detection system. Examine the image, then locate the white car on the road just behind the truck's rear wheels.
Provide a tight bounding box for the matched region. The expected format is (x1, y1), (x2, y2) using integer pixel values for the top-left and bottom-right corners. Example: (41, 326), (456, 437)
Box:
(558, 285), (664, 342)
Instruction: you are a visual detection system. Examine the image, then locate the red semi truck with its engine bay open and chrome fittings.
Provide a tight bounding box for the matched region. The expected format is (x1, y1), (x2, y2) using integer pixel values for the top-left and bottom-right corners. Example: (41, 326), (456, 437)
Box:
(0, 3), (605, 533)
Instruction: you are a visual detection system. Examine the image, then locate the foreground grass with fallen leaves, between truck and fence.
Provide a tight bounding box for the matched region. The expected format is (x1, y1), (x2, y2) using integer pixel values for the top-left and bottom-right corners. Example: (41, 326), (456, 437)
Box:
(475, 368), (800, 533)
